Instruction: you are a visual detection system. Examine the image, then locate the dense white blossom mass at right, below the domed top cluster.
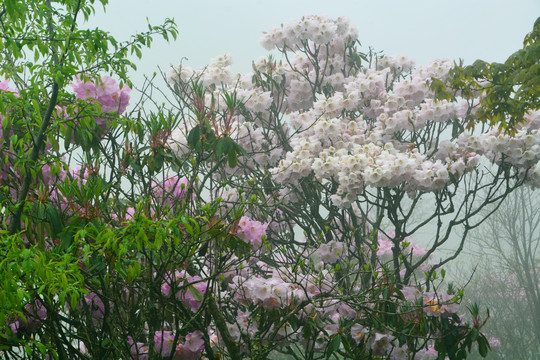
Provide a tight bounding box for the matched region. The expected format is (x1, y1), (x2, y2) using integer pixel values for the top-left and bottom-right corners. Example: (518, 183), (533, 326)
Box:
(272, 53), (540, 206)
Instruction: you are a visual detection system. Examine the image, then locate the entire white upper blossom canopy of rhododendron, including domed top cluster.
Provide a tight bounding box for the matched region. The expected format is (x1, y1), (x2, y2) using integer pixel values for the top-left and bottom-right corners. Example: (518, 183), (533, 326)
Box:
(173, 16), (540, 207)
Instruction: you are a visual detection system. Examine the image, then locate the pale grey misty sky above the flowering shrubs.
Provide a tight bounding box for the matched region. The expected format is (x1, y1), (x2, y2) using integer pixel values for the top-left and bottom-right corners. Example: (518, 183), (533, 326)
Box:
(87, 0), (540, 84)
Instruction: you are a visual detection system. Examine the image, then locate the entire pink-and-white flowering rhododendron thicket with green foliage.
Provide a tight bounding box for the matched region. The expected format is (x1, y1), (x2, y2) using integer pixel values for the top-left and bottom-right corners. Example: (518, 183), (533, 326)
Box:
(0, 2), (540, 359)
